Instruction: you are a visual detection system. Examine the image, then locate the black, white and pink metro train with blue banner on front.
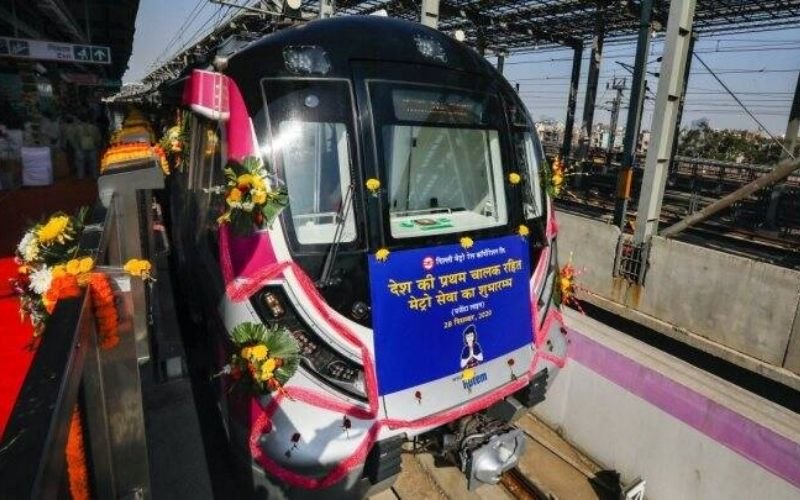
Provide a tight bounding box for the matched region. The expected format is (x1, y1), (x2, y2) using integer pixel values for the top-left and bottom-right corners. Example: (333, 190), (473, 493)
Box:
(169, 16), (568, 496)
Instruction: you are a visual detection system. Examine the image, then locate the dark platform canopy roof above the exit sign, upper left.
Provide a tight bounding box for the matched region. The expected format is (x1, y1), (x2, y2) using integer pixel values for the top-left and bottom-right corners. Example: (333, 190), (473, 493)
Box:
(0, 0), (139, 80)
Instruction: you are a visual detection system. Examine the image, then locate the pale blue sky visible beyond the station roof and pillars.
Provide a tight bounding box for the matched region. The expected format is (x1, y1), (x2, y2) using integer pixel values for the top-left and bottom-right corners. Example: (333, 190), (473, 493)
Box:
(123, 0), (800, 135)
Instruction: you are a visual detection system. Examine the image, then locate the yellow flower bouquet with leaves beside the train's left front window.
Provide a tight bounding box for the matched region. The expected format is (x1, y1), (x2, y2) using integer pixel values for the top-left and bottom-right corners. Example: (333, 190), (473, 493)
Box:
(217, 156), (289, 235)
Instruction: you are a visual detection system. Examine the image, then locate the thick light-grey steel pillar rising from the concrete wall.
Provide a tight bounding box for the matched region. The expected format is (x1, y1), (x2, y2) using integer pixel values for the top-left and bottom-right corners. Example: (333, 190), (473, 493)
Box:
(633, 0), (696, 245)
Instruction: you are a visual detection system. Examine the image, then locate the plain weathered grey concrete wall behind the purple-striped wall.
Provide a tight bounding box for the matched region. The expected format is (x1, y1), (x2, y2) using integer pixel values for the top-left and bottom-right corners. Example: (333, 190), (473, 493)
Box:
(558, 209), (800, 387)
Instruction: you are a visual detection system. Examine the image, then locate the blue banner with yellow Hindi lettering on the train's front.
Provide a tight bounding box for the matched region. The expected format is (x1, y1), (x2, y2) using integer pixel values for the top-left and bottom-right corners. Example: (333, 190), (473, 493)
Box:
(369, 236), (533, 395)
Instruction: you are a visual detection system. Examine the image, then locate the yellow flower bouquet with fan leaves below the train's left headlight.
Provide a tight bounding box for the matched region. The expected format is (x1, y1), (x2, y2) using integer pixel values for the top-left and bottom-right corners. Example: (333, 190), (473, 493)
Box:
(219, 322), (300, 395)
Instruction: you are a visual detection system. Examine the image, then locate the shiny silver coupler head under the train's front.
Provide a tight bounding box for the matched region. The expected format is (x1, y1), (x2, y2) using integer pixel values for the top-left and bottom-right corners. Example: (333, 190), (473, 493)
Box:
(464, 429), (525, 490)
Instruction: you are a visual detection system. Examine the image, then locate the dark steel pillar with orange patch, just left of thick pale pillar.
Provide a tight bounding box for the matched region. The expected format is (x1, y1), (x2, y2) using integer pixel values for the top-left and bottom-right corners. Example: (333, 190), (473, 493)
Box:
(614, 0), (652, 231)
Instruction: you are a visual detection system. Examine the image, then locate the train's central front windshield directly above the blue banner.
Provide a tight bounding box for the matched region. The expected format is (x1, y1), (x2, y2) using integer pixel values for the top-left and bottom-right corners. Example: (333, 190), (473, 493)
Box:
(369, 81), (508, 238)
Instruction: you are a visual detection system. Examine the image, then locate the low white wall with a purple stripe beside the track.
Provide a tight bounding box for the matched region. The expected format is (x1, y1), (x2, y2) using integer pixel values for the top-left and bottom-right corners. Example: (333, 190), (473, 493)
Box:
(534, 311), (800, 500)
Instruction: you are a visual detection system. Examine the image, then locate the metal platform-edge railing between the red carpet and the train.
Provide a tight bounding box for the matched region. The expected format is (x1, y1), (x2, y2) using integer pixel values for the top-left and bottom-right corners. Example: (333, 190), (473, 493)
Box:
(0, 160), (163, 499)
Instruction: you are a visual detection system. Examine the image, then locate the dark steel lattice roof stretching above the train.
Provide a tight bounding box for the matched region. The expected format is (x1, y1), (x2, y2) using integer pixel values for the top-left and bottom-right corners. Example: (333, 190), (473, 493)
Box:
(116, 0), (800, 100)
